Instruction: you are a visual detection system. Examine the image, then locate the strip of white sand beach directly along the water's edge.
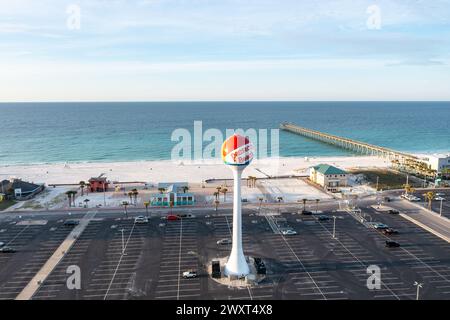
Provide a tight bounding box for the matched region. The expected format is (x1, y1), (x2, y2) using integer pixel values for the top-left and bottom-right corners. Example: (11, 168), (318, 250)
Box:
(0, 156), (390, 185)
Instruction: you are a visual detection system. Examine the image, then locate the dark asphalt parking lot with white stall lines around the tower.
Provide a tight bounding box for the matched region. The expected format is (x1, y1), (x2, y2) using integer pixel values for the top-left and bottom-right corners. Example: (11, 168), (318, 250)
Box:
(0, 207), (450, 300)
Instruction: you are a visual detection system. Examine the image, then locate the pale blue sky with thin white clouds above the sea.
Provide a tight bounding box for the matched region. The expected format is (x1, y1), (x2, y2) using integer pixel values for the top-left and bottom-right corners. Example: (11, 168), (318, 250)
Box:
(0, 0), (450, 101)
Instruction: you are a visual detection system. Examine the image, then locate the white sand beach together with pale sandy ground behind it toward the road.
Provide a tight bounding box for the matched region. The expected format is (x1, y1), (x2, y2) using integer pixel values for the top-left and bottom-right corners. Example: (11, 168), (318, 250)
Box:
(0, 157), (389, 211)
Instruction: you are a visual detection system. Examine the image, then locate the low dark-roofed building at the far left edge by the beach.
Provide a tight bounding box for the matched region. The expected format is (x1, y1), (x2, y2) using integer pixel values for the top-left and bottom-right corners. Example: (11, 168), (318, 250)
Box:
(0, 178), (45, 201)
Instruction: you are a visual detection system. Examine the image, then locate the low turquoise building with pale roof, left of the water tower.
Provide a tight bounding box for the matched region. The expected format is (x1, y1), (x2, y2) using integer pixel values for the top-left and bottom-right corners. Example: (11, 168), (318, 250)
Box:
(150, 182), (195, 207)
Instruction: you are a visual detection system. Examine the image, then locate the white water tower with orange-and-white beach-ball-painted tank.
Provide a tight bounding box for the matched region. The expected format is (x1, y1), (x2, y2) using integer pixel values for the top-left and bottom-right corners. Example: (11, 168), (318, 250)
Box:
(222, 134), (253, 277)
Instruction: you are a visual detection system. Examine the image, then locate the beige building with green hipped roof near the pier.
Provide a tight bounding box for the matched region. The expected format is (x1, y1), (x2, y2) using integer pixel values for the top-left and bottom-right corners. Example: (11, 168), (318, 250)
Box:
(309, 164), (348, 192)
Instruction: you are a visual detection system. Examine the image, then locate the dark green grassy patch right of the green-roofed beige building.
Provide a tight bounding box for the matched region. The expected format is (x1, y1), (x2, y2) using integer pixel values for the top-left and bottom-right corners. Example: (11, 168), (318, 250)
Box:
(351, 169), (421, 190)
